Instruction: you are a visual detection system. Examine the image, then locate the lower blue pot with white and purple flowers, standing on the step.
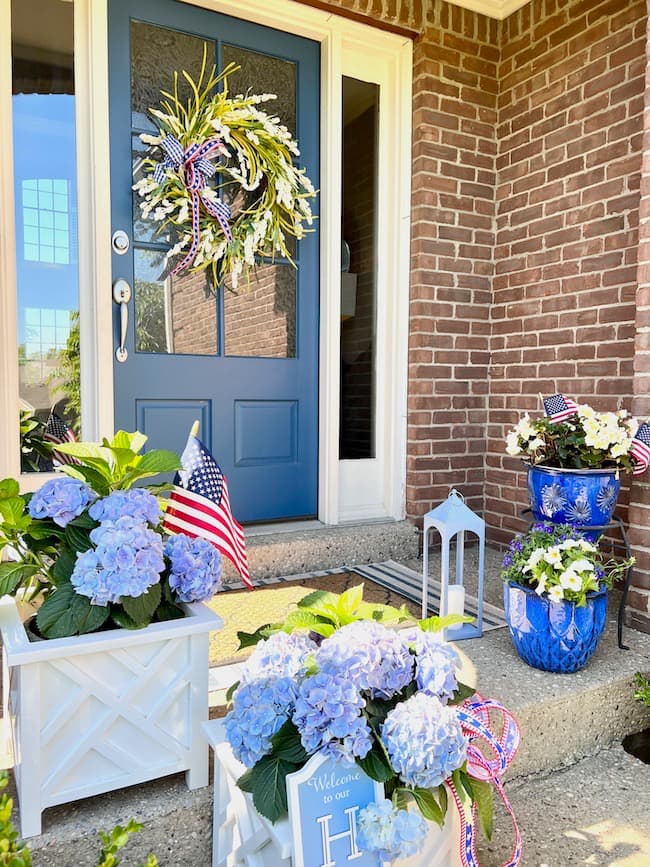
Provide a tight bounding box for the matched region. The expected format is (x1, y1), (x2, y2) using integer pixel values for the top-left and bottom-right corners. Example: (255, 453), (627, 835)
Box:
(501, 522), (633, 672)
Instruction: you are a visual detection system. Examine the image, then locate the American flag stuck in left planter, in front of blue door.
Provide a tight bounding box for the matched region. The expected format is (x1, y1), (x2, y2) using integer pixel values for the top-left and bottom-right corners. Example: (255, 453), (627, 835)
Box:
(163, 434), (253, 590)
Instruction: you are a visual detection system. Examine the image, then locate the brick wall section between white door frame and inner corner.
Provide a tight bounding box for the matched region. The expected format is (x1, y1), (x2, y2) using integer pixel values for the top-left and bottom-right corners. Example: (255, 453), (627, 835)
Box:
(406, 3), (499, 521)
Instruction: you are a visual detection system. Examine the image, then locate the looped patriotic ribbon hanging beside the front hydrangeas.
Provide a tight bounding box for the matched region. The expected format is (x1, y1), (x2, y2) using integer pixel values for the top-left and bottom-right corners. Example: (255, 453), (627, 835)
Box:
(446, 693), (523, 867)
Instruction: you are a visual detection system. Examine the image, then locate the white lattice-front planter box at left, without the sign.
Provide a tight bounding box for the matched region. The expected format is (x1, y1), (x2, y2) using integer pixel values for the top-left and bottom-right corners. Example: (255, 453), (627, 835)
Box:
(0, 597), (223, 837)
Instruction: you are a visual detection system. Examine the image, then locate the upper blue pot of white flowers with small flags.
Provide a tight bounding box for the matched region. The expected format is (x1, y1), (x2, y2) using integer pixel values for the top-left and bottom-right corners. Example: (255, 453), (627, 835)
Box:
(506, 395), (650, 527)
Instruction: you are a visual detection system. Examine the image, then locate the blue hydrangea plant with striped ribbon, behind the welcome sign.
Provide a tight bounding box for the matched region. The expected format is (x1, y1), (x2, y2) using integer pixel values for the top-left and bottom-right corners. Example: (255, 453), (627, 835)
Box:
(224, 586), (521, 865)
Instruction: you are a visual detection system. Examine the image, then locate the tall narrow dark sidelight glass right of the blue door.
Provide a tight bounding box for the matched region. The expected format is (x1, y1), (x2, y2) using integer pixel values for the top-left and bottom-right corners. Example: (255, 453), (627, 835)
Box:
(339, 78), (379, 459)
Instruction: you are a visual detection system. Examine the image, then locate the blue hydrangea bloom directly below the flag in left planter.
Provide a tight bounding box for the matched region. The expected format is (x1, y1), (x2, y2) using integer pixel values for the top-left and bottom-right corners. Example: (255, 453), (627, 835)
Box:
(165, 533), (221, 602)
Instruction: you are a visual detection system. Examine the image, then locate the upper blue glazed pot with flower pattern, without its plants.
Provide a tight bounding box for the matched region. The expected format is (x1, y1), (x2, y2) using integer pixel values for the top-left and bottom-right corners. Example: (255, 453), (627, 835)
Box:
(528, 466), (621, 541)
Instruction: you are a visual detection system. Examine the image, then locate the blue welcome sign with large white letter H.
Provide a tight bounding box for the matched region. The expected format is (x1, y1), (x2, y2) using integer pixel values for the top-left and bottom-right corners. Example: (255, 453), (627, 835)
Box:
(287, 754), (385, 867)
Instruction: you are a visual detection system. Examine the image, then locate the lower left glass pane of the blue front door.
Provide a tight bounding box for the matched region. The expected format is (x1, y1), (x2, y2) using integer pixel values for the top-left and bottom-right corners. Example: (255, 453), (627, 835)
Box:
(133, 250), (217, 355)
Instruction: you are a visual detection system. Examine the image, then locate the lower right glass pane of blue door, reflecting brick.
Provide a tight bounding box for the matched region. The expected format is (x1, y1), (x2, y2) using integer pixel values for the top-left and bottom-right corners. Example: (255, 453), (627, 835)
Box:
(223, 265), (296, 358)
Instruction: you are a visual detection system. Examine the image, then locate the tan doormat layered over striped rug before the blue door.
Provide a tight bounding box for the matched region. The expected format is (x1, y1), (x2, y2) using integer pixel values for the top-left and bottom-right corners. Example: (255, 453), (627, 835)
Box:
(208, 560), (505, 666)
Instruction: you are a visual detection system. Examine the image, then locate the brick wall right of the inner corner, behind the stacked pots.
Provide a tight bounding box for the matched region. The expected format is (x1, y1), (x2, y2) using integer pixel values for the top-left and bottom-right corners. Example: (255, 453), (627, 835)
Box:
(485, 0), (646, 541)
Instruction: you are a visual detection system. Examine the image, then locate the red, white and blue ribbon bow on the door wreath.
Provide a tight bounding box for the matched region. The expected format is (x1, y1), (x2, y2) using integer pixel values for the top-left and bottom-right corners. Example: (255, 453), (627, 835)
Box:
(153, 135), (232, 277)
